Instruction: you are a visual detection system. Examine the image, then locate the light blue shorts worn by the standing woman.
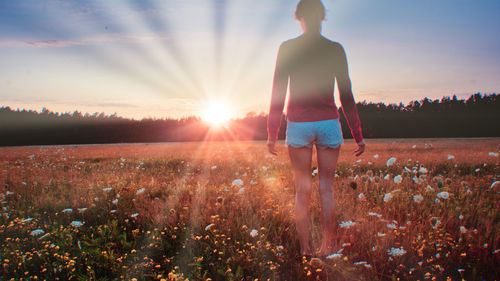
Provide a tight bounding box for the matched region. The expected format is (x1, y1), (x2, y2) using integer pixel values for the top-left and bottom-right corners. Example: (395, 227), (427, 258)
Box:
(286, 118), (344, 149)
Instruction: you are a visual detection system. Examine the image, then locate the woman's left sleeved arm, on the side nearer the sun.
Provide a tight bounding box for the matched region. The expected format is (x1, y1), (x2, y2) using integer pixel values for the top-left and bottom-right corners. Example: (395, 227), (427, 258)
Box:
(267, 44), (289, 143)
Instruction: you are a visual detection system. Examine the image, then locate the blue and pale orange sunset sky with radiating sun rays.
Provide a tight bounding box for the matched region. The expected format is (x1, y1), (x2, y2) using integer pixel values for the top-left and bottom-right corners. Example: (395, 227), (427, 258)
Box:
(0, 0), (500, 119)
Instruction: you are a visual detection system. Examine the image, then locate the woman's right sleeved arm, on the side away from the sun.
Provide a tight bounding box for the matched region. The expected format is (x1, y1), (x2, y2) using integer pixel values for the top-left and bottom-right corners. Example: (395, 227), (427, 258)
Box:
(337, 45), (365, 153)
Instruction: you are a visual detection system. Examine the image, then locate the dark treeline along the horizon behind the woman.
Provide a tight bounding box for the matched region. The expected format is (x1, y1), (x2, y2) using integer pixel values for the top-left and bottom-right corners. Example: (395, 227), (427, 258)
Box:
(0, 93), (500, 146)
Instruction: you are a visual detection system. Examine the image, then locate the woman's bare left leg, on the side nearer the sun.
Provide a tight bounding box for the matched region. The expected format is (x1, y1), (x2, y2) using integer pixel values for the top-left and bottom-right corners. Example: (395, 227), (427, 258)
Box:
(288, 146), (312, 255)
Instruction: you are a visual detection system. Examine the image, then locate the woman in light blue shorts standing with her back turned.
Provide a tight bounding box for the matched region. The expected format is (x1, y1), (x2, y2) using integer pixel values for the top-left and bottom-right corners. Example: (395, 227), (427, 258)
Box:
(267, 0), (365, 256)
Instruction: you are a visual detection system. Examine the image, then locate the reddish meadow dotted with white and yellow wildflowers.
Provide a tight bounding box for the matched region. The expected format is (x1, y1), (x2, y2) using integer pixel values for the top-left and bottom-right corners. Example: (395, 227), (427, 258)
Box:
(0, 139), (500, 280)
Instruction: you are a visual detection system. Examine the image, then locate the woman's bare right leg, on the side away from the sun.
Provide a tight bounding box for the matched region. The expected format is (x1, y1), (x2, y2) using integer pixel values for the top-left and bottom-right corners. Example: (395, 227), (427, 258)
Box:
(317, 147), (340, 255)
